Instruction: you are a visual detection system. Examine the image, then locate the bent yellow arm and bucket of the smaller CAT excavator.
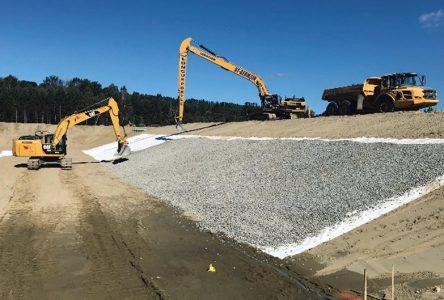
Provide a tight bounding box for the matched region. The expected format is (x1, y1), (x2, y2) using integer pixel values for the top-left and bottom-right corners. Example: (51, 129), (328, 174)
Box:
(51, 97), (130, 156)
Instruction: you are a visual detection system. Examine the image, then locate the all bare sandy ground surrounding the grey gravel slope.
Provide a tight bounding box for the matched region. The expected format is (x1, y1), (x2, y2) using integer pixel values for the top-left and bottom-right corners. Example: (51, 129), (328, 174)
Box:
(0, 112), (444, 299)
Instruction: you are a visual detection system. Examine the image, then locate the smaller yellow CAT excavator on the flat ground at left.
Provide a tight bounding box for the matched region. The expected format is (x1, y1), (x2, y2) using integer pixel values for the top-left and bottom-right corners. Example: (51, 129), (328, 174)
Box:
(12, 98), (131, 170)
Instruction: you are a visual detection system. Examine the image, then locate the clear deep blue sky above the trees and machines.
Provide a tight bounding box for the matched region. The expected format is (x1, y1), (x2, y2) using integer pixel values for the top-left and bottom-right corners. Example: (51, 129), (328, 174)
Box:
(0, 0), (444, 112)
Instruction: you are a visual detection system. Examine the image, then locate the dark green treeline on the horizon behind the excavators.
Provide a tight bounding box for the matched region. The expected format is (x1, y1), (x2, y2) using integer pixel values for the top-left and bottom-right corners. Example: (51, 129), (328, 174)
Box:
(0, 75), (260, 126)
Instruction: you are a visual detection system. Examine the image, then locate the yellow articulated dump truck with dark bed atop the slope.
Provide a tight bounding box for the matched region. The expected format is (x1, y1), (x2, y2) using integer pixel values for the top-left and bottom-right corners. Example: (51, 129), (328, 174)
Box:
(322, 73), (439, 116)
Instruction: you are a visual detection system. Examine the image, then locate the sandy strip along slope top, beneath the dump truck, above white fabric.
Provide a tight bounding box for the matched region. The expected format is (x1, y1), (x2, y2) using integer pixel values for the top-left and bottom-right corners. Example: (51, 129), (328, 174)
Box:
(145, 111), (444, 138)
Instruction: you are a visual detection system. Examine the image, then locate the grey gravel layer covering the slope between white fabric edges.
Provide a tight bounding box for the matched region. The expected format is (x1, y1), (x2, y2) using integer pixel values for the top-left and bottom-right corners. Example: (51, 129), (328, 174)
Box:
(109, 138), (444, 247)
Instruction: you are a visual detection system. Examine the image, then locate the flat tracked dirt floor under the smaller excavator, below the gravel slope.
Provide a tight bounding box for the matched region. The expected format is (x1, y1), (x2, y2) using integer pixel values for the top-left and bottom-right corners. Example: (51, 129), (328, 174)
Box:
(0, 123), (320, 299)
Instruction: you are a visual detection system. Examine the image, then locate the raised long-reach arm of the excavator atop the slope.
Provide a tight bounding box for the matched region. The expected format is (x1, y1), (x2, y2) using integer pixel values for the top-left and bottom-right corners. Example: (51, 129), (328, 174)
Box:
(176, 38), (270, 126)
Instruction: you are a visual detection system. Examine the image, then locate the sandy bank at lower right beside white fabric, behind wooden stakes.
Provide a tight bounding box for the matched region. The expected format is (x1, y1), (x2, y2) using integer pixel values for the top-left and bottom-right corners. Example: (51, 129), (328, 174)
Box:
(287, 188), (444, 299)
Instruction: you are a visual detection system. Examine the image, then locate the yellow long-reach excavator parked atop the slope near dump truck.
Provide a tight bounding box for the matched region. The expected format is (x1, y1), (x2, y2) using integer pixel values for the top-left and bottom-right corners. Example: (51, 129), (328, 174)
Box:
(176, 38), (311, 127)
